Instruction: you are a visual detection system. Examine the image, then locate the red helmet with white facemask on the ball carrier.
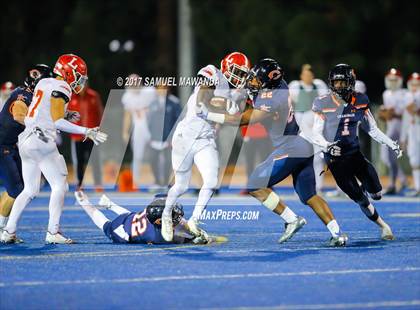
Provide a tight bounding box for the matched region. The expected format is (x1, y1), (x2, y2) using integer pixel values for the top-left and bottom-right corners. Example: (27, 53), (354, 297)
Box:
(220, 52), (251, 88)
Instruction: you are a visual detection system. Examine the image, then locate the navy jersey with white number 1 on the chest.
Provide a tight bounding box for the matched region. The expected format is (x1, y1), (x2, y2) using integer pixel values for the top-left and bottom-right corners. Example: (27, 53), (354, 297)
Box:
(312, 93), (369, 155)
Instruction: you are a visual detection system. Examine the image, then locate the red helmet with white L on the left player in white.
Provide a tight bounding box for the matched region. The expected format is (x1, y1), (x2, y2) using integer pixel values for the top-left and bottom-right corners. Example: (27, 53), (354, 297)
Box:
(54, 54), (88, 94)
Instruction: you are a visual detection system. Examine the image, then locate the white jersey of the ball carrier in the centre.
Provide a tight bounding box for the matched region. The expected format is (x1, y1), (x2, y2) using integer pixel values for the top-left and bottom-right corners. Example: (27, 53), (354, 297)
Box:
(177, 65), (232, 138)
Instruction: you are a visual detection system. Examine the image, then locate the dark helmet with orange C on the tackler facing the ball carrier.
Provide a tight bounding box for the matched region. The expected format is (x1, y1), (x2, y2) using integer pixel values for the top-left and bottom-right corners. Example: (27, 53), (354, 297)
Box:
(246, 58), (284, 97)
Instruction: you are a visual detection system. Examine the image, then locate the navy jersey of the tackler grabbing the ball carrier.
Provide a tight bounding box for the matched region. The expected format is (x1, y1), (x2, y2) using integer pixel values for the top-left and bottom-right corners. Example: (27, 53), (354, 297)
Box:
(253, 80), (313, 157)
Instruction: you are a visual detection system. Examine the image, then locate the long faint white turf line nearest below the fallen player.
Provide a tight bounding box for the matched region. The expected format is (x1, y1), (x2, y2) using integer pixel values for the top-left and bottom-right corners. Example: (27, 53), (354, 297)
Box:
(0, 243), (416, 261)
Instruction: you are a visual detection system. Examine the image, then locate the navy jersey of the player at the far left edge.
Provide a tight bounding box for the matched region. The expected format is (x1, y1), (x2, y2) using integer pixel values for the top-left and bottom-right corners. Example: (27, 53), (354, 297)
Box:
(0, 87), (32, 146)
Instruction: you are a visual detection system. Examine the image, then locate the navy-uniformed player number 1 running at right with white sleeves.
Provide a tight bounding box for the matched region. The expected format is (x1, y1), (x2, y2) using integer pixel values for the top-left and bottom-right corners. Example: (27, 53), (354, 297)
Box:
(312, 64), (402, 240)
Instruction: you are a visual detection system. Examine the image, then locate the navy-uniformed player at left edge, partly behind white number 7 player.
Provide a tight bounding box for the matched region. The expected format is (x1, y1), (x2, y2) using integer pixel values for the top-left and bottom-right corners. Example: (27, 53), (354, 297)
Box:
(0, 64), (53, 230)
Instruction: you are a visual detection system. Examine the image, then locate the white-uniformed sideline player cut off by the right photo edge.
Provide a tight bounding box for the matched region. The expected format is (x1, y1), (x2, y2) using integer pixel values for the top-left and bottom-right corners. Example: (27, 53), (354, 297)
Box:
(401, 72), (420, 197)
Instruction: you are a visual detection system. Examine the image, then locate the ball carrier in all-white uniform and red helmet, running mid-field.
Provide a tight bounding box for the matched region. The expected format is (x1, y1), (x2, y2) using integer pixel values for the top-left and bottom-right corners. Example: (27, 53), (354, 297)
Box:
(162, 52), (251, 241)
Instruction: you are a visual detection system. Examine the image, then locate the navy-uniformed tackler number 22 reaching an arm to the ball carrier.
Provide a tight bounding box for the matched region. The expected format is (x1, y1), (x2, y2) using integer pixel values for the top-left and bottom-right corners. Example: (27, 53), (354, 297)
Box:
(197, 58), (348, 246)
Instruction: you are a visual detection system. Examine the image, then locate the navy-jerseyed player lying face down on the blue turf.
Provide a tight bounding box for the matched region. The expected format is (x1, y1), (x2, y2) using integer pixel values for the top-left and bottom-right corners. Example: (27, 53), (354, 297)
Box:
(74, 191), (213, 244)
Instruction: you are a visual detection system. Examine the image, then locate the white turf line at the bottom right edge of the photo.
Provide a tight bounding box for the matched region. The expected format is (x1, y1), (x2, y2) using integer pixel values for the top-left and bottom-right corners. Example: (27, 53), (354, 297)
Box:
(212, 299), (420, 310)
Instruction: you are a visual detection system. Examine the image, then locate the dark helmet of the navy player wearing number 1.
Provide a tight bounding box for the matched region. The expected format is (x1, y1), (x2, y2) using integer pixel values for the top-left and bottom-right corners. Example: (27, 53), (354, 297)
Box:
(328, 64), (356, 102)
